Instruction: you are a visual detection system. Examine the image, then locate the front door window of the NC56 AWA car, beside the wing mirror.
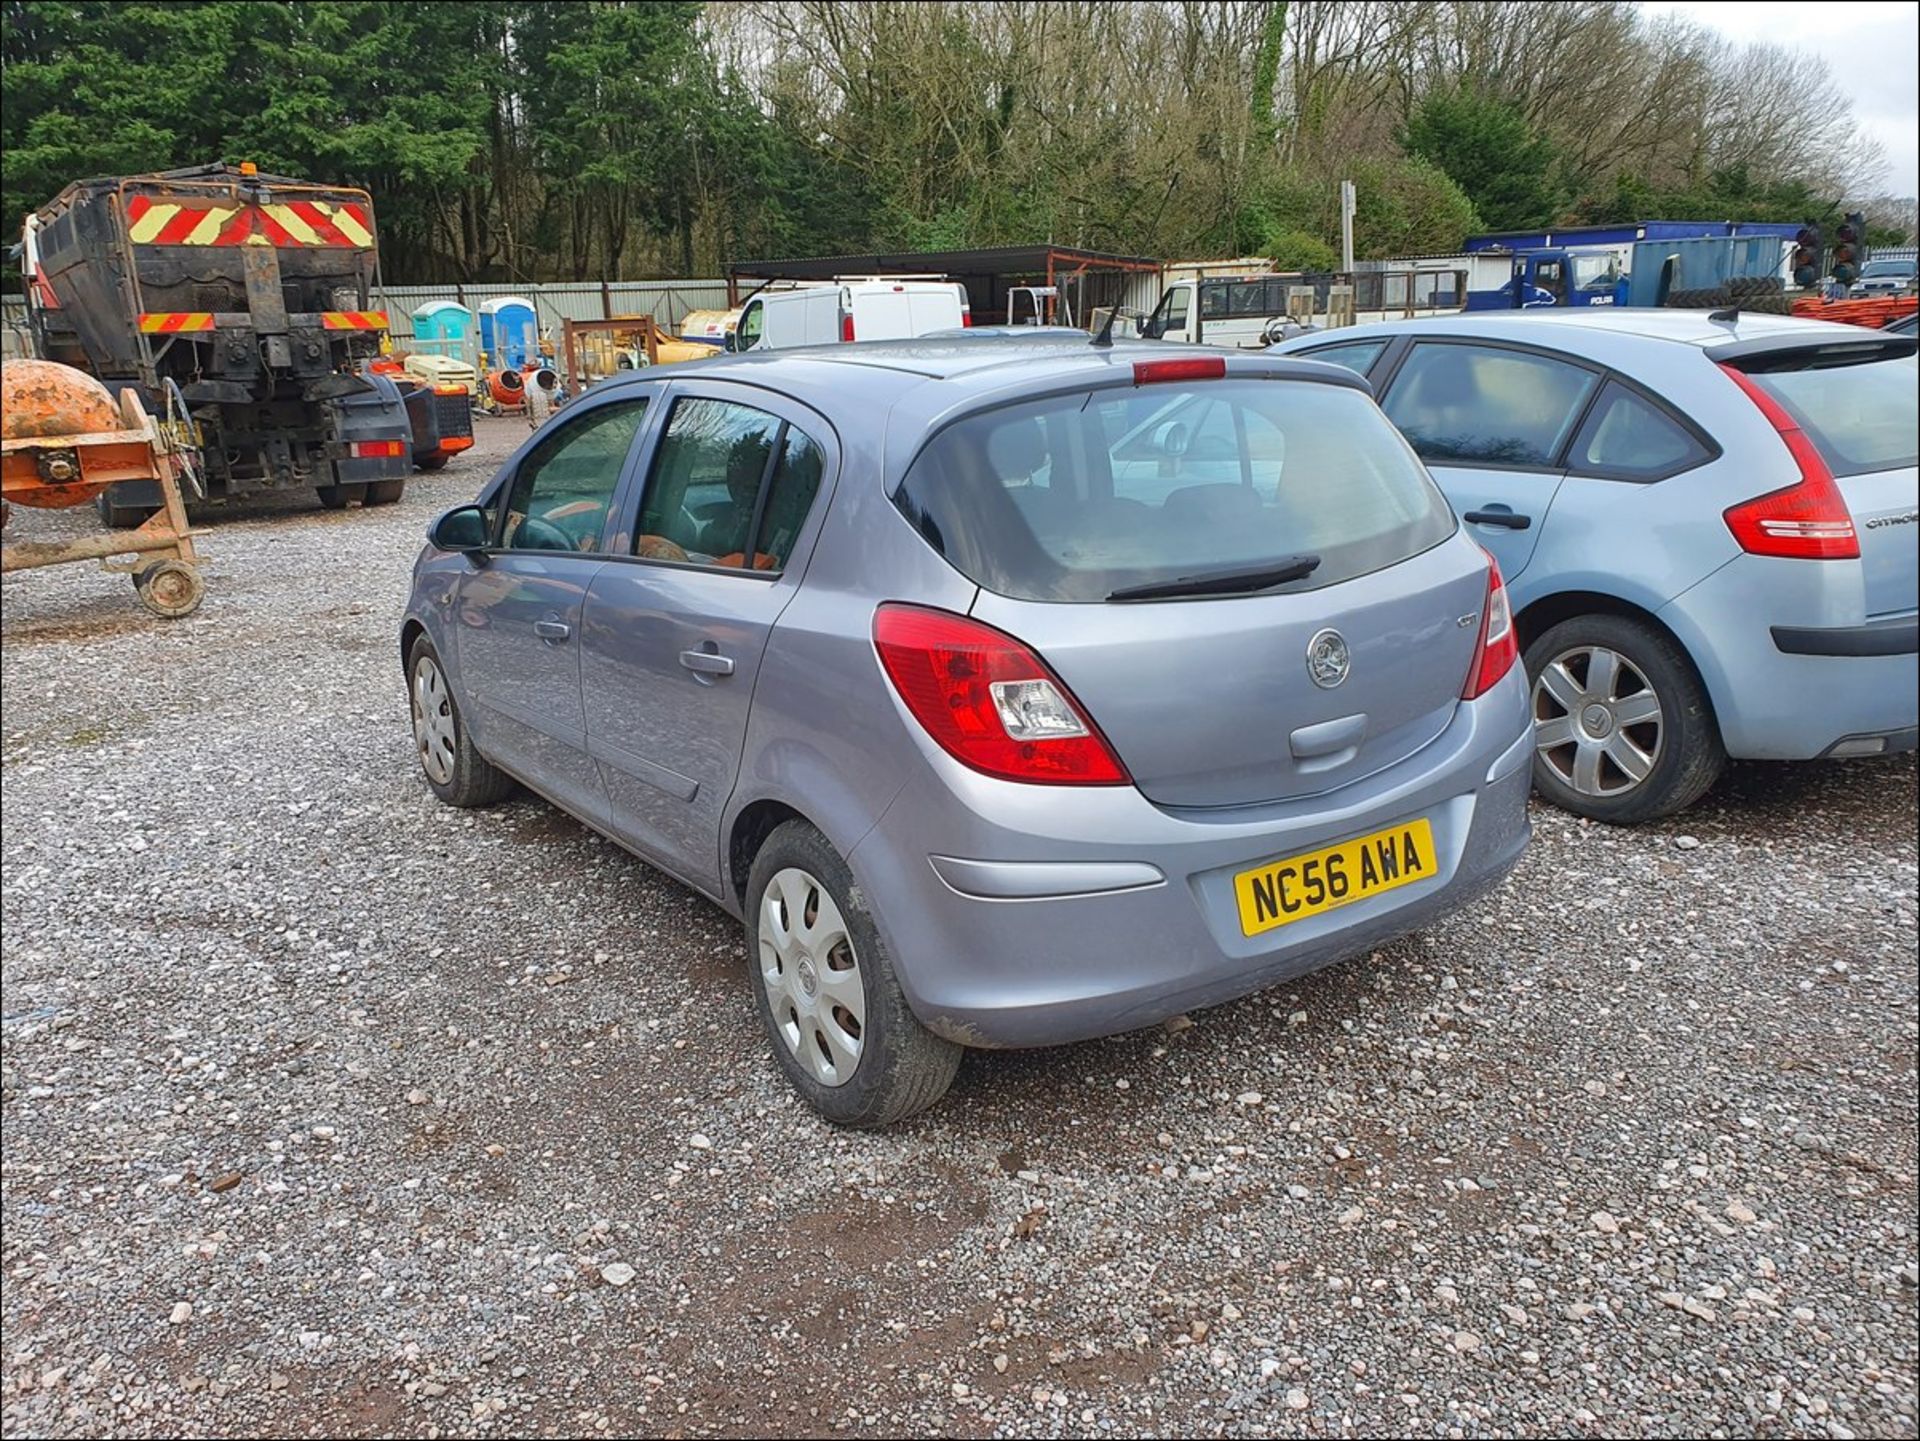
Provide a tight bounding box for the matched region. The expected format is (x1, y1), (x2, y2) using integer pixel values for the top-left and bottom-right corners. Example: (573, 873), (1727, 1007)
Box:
(501, 397), (647, 551)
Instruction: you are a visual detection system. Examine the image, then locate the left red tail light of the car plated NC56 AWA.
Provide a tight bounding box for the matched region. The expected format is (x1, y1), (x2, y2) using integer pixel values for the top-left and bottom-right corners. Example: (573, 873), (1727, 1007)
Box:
(874, 604), (1129, 785)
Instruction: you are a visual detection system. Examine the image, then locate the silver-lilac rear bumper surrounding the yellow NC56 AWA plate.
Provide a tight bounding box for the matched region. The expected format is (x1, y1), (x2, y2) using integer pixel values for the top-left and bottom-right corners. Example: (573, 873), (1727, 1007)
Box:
(849, 670), (1532, 1046)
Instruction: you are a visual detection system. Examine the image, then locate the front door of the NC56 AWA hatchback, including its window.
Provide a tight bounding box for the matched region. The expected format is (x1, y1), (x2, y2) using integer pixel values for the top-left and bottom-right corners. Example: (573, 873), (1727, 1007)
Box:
(455, 395), (649, 823)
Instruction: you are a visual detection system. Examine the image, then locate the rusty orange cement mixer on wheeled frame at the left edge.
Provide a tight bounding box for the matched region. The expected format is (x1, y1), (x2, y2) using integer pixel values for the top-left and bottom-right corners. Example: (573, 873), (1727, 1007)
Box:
(0, 361), (205, 616)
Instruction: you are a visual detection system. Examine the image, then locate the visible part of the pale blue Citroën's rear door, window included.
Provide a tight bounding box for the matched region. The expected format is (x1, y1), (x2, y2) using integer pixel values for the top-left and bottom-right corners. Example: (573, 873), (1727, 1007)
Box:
(1377, 340), (1601, 581)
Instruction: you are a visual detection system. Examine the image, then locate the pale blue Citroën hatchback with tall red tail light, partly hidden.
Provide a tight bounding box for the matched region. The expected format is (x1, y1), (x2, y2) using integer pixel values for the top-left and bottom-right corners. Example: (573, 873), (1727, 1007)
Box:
(1281, 309), (1920, 825)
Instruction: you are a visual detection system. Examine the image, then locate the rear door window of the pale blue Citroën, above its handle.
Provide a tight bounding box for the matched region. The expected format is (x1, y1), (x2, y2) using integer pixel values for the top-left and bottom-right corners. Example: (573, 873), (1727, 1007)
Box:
(1380, 342), (1599, 466)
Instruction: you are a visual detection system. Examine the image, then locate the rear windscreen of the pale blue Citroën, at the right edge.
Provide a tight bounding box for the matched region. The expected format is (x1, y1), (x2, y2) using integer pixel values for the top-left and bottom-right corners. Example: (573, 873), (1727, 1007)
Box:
(1743, 351), (1920, 476)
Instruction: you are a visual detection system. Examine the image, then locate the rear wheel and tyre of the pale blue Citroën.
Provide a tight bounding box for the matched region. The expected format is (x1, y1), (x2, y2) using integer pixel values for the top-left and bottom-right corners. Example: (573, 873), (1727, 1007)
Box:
(1524, 616), (1726, 825)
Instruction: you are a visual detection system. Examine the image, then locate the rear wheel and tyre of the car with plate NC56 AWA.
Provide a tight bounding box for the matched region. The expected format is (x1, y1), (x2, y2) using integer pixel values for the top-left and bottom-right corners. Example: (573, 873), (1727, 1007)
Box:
(745, 821), (962, 1130)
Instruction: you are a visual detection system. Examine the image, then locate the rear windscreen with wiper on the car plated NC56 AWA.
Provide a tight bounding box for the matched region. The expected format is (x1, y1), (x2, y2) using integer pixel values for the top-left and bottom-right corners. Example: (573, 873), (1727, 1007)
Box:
(895, 380), (1453, 601)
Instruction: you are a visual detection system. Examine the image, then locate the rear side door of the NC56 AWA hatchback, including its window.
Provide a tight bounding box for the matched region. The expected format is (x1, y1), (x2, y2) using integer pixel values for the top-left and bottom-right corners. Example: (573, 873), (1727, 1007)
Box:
(580, 382), (837, 890)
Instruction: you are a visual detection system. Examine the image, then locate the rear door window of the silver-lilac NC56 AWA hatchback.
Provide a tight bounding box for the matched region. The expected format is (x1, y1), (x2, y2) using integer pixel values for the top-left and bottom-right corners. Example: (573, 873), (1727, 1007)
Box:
(634, 397), (822, 572)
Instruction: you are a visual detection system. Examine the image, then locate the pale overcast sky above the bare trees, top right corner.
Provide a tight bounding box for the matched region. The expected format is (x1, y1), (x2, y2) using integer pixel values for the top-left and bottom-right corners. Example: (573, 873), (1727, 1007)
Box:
(1647, 0), (1920, 196)
